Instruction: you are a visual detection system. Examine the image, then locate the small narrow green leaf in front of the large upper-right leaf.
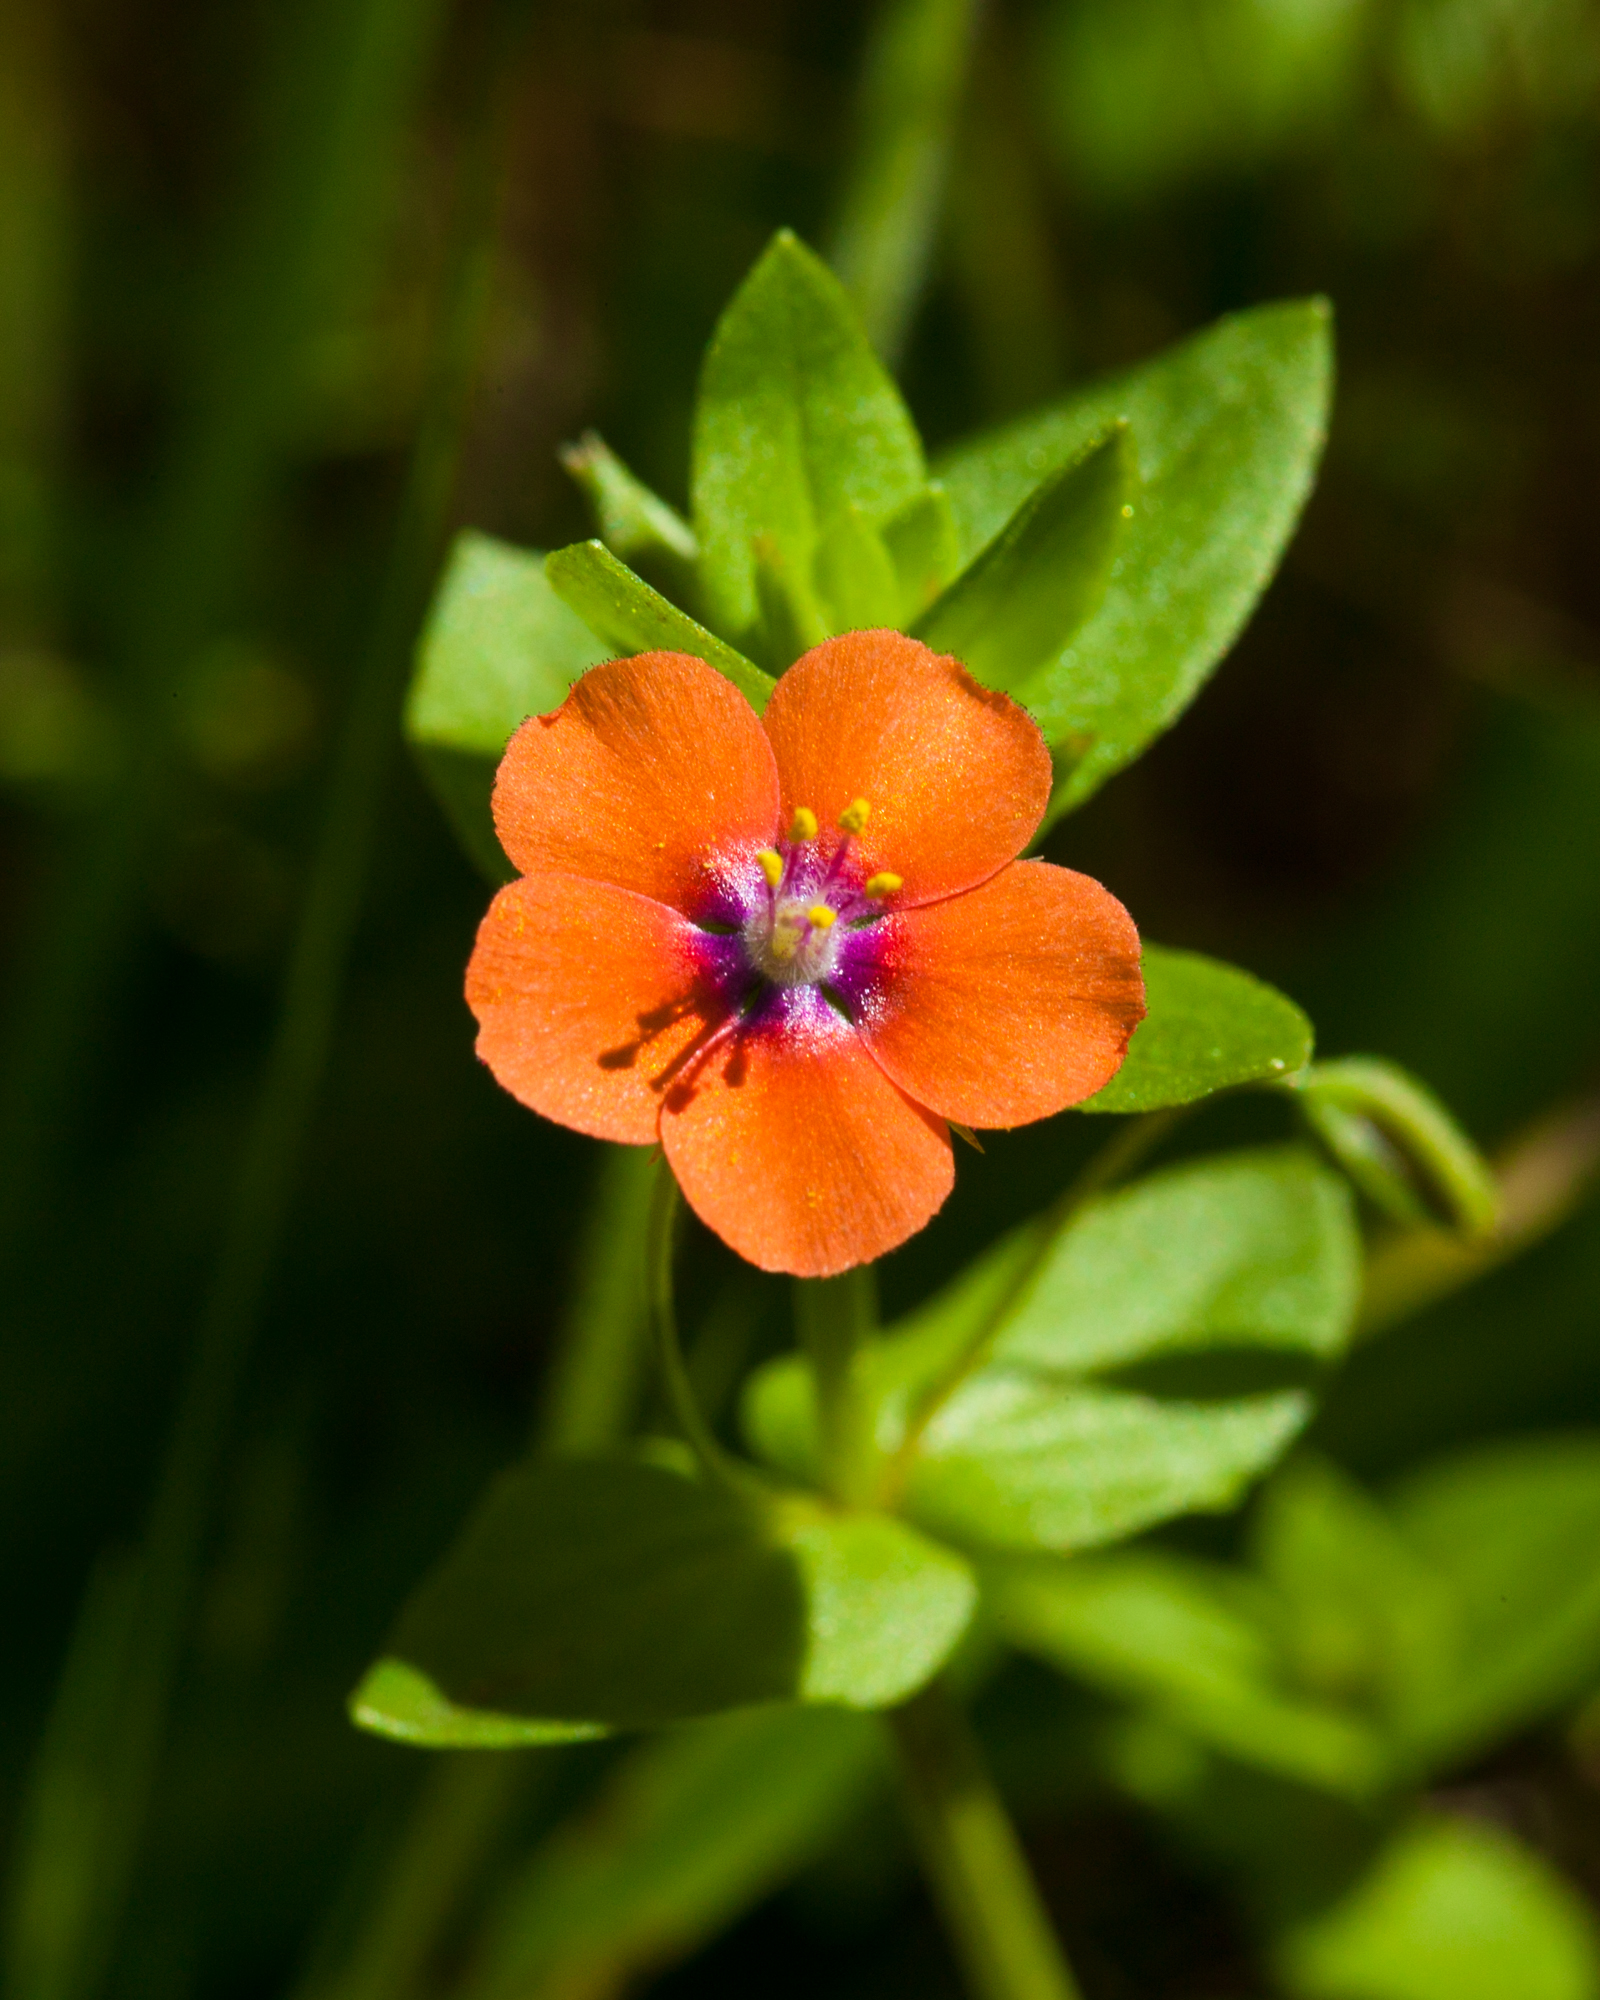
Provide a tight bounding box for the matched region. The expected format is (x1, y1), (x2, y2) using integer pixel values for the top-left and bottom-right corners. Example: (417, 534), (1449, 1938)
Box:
(916, 424), (1136, 690)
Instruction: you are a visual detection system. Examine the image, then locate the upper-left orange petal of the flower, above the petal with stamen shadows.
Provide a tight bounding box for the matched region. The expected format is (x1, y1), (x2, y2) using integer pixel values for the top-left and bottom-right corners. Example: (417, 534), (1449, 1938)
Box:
(494, 652), (778, 914)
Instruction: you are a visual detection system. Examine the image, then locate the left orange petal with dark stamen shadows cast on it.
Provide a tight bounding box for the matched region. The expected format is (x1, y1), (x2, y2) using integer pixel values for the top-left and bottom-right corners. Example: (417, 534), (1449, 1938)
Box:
(466, 874), (742, 1146)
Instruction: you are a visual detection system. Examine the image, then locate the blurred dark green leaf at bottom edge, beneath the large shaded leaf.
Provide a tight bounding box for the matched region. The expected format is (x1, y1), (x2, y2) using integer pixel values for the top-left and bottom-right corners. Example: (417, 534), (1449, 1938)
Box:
(462, 1708), (884, 2000)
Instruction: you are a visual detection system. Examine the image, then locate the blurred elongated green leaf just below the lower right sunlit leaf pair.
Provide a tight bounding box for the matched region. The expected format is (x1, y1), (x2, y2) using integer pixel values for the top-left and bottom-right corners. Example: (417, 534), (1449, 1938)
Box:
(984, 1552), (1384, 1798)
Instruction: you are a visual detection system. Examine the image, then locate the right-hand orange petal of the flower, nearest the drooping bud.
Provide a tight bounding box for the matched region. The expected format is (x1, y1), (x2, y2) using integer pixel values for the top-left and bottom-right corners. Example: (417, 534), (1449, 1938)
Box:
(850, 862), (1144, 1126)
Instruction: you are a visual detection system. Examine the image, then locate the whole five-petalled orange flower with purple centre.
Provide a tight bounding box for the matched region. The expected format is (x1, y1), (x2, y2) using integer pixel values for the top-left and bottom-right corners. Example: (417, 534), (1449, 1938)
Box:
(466, 632), (1144, 1278)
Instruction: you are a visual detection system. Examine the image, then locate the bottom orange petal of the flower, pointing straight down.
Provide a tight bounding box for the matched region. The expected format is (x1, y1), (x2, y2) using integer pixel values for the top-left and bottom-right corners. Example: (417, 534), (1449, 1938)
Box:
(662, 988), (956, 1278)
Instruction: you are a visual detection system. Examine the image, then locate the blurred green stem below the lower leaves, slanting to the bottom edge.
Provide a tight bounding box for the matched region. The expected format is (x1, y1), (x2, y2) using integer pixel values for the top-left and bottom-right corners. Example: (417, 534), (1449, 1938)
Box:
(888, 1682), (1080, 2000)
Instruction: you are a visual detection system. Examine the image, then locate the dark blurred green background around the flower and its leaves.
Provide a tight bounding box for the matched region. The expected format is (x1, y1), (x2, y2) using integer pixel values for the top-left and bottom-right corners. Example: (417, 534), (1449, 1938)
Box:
(0, 0), (1600, 2000)
